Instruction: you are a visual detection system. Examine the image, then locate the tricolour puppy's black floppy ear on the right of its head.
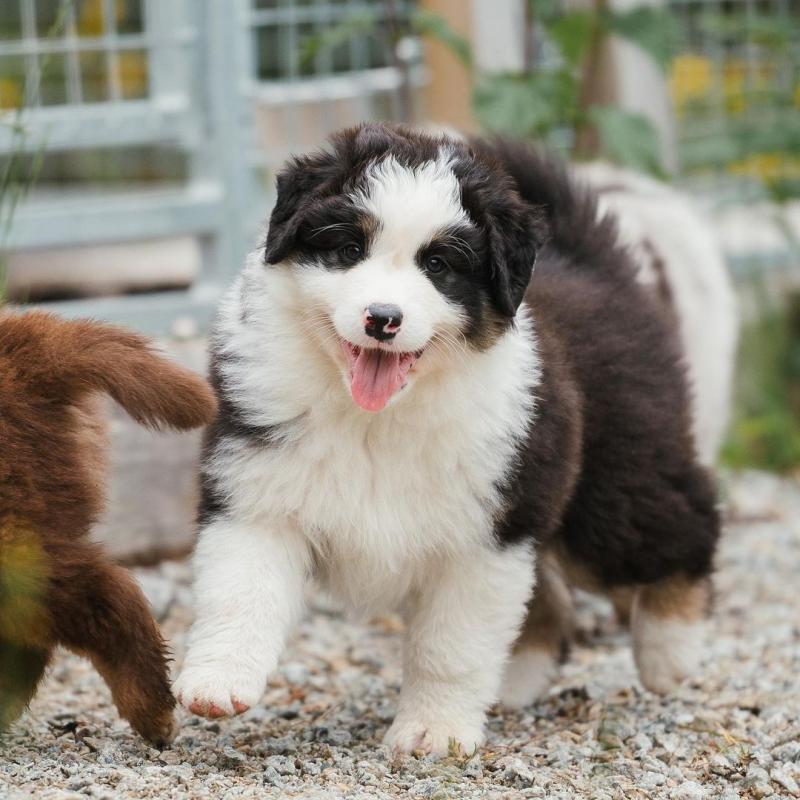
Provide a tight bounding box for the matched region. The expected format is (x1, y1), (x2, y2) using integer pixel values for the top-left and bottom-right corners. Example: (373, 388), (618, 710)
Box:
(487, 198), (547, 317)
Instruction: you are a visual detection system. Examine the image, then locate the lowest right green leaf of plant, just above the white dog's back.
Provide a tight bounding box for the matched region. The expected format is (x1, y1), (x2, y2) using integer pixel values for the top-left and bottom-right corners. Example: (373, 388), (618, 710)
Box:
(589, 106), (663, 175)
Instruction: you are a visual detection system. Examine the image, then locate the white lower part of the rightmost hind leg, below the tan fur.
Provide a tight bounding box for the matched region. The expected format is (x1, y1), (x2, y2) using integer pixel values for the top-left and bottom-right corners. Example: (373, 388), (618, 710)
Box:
(632, 612), (705, 694)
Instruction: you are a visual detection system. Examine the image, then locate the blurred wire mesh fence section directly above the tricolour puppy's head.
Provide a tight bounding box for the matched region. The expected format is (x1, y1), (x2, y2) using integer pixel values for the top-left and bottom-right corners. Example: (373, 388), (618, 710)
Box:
(250, 0), (422, 167)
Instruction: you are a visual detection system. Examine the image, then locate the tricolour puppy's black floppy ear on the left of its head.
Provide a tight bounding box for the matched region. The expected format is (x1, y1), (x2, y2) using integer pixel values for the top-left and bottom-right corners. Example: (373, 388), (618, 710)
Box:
(264, 152), (336, 264)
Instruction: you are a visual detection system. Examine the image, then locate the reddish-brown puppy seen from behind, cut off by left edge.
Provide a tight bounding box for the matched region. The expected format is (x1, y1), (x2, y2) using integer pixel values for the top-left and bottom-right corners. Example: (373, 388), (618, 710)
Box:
(0, 312), (216, 745)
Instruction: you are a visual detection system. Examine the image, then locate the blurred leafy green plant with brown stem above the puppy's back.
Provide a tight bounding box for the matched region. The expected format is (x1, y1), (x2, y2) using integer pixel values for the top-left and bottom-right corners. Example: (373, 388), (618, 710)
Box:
(475, 0), (677, 174)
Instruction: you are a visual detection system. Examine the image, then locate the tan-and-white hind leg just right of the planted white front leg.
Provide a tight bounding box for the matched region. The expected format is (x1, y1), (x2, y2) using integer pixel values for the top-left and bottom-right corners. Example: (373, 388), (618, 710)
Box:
(500, 557), (573, 708)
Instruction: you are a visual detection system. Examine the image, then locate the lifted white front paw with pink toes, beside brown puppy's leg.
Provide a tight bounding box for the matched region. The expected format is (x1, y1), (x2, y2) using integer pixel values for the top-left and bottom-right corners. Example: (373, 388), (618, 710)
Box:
(172, 664), (264, 719)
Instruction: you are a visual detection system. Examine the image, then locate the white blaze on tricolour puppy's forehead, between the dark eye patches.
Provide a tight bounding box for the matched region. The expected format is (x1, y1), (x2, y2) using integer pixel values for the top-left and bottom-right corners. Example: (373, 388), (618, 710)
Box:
(354, 152), (469, 250)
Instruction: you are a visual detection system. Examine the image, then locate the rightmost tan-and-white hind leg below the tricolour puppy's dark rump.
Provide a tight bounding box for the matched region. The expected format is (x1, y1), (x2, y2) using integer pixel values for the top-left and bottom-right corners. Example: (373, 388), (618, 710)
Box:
(631, 576), (711, 694)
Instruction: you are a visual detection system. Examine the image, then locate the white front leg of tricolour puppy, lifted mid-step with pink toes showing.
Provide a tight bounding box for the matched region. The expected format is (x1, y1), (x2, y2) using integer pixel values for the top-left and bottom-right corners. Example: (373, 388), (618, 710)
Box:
(174, 519), (309, 717)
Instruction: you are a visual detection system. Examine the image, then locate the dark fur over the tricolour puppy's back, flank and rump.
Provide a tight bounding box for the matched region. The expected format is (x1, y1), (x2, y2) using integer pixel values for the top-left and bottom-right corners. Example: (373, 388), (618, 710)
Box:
(482, 143), (719, 586)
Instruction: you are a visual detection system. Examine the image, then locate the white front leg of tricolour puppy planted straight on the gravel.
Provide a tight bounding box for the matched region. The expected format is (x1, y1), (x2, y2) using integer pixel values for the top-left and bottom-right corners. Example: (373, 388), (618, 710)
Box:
(385, 546), (534, 755)
